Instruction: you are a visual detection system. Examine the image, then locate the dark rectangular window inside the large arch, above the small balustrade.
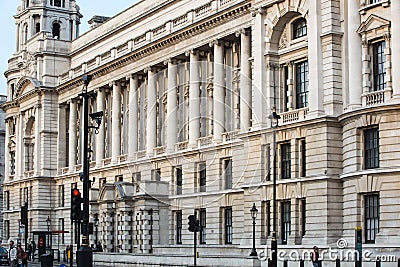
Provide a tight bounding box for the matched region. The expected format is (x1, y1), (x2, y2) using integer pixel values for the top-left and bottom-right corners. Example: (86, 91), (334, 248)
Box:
(296, 61), (308, 109)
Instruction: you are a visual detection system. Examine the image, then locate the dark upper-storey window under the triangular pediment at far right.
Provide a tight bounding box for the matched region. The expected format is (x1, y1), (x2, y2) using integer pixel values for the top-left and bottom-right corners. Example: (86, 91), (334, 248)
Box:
(373, 41), (386, 91)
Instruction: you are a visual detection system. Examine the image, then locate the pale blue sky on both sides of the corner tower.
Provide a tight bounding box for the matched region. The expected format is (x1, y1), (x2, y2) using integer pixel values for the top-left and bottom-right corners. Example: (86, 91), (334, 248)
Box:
(0, 0), (138, 95)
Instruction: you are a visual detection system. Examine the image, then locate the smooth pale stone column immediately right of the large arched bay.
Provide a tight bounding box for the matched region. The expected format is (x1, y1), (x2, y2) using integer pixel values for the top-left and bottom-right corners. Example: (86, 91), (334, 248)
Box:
(307, 0), (324, 116)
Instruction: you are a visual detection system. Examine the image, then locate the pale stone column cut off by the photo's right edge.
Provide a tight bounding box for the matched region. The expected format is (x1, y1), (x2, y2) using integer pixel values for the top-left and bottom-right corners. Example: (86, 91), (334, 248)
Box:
(390, 0), (400, 98)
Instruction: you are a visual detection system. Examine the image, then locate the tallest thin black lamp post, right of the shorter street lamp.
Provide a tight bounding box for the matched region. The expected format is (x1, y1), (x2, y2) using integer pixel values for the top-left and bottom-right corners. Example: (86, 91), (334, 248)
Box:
(269, 107), (281, 267)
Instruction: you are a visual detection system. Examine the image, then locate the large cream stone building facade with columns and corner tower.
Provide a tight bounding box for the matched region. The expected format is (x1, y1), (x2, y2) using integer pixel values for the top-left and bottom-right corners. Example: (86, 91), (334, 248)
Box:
(3, 0), (400, 266)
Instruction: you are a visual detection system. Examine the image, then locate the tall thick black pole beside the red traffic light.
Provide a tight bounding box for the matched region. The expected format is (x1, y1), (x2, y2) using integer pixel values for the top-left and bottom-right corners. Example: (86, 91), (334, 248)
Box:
(76, 75), (93, 267)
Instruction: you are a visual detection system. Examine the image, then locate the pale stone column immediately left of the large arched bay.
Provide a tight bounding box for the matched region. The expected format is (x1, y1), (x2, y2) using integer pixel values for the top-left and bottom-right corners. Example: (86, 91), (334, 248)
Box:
(252, 8), (271, 129)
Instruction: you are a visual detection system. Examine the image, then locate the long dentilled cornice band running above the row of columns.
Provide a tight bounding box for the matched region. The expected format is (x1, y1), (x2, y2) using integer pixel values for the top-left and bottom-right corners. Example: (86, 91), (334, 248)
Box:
(57, 0), (251, 94)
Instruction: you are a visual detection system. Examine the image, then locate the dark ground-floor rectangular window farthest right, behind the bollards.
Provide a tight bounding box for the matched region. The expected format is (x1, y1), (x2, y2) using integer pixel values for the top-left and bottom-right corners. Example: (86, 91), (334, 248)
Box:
(364, 194), (379, 243)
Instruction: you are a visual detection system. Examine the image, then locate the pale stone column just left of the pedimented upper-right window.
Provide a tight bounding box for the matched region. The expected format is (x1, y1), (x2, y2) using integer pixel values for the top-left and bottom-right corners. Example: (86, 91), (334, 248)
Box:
(348, 0), (363, 110)
